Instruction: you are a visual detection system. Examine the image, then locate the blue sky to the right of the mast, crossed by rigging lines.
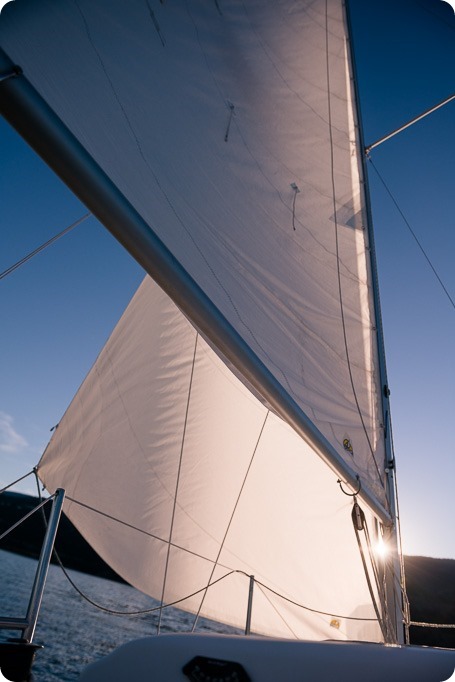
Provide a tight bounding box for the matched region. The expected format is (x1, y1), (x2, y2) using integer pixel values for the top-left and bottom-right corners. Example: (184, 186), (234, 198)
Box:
(351, 0), (455, 558)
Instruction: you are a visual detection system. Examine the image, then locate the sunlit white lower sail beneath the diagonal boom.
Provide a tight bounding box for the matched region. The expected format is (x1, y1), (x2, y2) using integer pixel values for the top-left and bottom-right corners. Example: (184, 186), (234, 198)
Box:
(39, 278), (381, 640)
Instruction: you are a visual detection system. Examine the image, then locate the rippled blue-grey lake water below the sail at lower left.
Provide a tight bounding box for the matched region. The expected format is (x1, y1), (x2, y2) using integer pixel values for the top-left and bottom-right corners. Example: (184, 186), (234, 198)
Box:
(0, 551), (240, 682)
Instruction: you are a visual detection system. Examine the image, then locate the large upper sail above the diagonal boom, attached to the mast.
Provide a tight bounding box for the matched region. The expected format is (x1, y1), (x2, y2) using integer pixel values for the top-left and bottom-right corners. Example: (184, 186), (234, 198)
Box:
(0, 0), (387, 505)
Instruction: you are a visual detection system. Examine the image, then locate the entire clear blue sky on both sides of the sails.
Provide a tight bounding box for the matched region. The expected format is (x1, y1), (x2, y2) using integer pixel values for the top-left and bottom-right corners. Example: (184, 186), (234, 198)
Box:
(0, 0), (455, 558)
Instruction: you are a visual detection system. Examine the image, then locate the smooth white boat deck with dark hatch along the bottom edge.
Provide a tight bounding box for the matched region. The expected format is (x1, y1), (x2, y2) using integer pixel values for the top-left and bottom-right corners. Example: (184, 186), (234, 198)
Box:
(80, 634), (455, 682)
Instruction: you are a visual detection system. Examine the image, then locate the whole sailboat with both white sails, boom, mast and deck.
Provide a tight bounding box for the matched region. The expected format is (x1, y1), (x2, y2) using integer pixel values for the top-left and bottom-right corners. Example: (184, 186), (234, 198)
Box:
(0, 0), (454, 681)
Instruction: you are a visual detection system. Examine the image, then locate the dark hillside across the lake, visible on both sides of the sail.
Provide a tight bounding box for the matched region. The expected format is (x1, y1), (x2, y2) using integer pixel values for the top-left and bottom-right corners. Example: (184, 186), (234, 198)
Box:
(0, 493), (455, 649)
